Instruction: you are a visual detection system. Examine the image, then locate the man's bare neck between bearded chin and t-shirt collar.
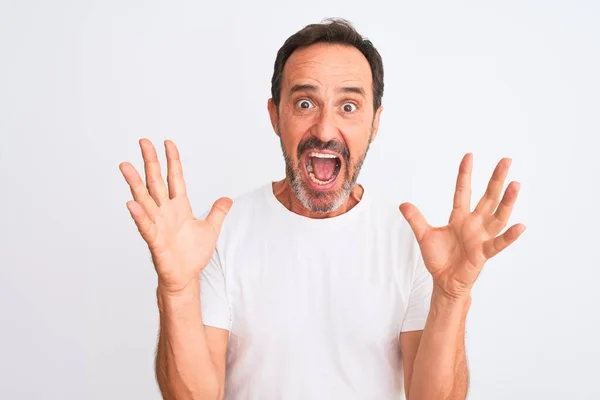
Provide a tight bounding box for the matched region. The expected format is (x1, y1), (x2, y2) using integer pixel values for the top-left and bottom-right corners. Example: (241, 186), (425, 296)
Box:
(273, 178), (364, 219)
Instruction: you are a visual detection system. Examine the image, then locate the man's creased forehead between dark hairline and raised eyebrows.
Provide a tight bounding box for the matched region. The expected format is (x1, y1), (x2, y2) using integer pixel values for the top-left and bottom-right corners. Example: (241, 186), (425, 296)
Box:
(282, 43), (373, 94)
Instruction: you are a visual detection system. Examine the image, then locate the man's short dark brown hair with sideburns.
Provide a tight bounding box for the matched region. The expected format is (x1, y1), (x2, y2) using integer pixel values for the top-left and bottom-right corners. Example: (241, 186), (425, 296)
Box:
(271, 19), (383, 111)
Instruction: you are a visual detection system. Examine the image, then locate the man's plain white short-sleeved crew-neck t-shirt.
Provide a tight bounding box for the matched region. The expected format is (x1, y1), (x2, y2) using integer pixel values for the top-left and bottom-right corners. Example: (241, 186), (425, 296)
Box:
(200, 183), (432, 400)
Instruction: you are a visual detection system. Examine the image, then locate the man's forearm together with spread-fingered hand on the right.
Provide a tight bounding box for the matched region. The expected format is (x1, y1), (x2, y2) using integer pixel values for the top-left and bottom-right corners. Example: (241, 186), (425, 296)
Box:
(400, 154), (525, 400)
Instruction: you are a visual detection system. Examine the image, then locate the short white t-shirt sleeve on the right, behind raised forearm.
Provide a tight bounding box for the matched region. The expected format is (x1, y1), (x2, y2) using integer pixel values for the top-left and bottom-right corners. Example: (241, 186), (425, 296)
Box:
(400, 246), (433, 332)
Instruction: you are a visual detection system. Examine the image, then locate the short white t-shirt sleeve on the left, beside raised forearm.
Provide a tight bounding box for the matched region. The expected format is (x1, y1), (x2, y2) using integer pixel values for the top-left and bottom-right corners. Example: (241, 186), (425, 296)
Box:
(200, 250), (231, 330)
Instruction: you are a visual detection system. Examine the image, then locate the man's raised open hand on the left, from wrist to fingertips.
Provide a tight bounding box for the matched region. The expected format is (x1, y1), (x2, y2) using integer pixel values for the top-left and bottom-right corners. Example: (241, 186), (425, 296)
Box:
(119, 139), (232, 295)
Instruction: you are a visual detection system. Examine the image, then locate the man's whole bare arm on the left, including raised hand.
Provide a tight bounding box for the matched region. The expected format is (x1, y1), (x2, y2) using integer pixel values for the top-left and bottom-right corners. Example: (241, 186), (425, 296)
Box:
(119, 139), (232, 400)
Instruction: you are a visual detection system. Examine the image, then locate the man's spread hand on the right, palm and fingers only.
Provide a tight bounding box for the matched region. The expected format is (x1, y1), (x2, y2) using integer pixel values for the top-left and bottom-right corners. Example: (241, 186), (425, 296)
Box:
(400, 154), (525, 297)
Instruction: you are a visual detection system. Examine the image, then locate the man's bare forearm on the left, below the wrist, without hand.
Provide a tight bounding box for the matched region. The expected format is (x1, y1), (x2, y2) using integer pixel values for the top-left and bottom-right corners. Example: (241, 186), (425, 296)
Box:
(156, 285), (219, 400)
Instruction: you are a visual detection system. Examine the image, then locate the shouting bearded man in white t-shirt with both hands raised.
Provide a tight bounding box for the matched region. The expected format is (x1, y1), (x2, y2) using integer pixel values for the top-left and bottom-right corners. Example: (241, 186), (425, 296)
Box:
(120, 20), (525, 400)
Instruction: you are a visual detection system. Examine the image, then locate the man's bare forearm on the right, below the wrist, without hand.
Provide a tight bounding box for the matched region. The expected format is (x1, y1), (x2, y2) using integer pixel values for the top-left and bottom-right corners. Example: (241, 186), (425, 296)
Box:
(409, 290), (471, 400)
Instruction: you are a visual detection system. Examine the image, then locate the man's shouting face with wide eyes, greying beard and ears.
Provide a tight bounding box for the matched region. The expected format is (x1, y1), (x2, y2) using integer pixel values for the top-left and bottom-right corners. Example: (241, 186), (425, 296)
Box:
(269, 44), (381, 213)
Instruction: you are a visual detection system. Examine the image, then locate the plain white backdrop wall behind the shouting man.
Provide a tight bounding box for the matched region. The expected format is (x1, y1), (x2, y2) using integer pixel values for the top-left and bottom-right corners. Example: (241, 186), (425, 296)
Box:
(0, 0), (600, 400)
